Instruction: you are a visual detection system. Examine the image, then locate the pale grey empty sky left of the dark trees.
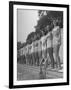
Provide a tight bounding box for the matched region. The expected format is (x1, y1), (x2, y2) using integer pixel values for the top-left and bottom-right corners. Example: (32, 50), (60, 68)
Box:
(17, 9), (38, 43)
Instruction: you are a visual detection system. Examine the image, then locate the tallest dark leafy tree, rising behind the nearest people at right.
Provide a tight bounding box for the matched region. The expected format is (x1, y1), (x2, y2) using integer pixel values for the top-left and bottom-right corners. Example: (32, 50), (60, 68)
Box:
(36, 10), (63, 34)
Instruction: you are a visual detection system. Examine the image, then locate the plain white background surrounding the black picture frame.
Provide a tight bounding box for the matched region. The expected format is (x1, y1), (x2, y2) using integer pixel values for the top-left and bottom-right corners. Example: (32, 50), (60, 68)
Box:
(0, 0), (71, 90)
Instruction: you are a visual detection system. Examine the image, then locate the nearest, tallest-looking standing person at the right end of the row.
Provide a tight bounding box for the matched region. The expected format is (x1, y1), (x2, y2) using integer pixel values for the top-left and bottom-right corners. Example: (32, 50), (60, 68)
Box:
(53, 26), (61, 68)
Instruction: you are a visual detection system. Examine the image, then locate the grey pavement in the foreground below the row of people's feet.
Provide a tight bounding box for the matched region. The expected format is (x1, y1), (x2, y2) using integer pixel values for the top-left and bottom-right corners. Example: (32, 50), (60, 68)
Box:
(17, 64), (63, 80)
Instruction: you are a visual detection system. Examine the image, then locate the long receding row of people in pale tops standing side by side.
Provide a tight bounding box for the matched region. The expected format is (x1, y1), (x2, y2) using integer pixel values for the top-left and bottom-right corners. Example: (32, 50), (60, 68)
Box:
(19, 26), (63, 68)
